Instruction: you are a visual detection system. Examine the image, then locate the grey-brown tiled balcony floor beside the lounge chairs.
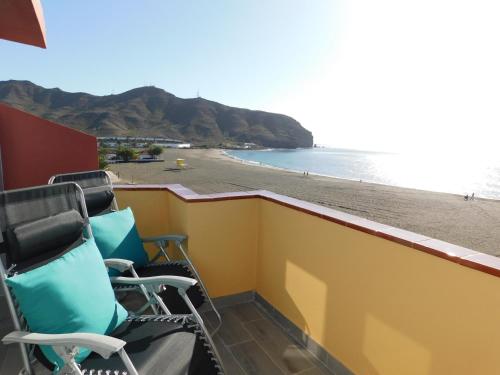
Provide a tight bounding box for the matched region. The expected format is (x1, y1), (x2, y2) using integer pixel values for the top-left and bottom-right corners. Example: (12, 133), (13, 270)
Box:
(0, 298), (330, 375)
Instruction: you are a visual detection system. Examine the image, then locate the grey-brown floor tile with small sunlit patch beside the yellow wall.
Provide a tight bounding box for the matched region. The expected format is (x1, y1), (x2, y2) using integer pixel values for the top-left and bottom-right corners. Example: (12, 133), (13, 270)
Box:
(244, 319), (314, 374)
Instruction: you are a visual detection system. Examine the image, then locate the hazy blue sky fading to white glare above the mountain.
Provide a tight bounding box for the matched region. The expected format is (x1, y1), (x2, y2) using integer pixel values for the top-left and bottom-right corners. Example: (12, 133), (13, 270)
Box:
(0, 0), (500, 152)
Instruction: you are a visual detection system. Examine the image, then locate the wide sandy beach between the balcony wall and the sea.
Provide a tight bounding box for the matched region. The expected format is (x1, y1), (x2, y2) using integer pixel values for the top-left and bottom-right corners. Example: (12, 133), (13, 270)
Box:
(109, 149), (500, 256)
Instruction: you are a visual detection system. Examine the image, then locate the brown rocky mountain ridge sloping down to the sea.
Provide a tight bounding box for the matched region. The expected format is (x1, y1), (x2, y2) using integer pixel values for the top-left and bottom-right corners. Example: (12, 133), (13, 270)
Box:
(0, 80), (313, 148)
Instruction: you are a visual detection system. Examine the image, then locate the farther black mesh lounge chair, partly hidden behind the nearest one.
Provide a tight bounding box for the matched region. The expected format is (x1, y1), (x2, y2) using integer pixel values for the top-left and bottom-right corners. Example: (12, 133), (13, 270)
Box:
(49, 170), (222, 334)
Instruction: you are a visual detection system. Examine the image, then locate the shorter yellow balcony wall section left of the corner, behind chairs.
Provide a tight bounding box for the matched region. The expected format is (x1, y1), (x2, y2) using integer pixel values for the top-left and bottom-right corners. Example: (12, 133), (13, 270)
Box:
(117, 190), (259, 297)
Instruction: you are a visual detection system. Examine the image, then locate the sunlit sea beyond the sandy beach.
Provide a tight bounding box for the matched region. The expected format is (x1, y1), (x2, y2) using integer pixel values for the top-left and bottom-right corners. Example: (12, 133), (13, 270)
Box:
(226, 148), (500, 199)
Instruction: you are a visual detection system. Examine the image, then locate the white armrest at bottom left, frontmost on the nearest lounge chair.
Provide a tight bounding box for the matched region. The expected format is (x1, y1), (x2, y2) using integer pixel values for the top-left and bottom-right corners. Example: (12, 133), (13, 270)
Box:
(2, 331), (126, 359)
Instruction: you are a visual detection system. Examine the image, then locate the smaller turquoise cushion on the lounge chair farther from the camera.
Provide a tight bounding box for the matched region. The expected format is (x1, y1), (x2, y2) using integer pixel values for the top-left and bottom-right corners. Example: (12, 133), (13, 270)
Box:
(90, 208), (149, 276)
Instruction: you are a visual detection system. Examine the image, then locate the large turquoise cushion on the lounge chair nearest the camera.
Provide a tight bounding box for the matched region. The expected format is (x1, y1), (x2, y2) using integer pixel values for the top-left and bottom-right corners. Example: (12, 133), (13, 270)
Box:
(6, 239), (128, 369)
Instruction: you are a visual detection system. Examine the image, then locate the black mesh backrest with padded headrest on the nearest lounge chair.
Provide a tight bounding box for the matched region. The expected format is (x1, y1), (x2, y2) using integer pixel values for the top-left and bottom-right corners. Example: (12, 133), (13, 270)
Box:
(0, 183), (92, 373)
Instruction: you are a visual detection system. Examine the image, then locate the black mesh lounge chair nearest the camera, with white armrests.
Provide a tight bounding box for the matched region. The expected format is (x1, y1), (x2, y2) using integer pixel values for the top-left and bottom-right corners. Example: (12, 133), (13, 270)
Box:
(0, 183), (224, 375)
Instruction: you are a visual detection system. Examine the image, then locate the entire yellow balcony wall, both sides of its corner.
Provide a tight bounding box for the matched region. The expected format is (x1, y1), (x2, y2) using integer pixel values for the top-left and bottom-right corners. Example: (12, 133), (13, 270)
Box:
(117, 189), (500, 375)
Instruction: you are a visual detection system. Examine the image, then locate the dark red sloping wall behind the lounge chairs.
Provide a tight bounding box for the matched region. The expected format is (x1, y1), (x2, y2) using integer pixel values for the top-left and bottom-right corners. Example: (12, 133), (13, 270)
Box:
(0, 103), (99, 190)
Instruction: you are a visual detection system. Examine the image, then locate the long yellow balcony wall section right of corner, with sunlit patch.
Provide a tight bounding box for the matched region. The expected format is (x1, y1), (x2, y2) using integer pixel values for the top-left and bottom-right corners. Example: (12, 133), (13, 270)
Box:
(257, 201), (500, 375)
